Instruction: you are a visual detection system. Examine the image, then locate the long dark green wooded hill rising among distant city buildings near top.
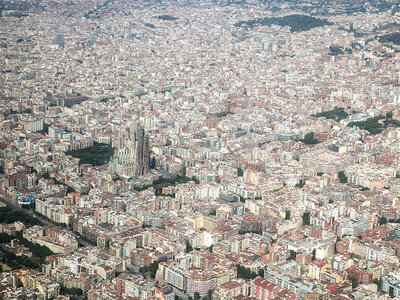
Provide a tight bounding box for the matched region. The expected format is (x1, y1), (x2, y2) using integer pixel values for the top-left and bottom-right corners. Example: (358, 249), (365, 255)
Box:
(235, 14), (333, 32)
